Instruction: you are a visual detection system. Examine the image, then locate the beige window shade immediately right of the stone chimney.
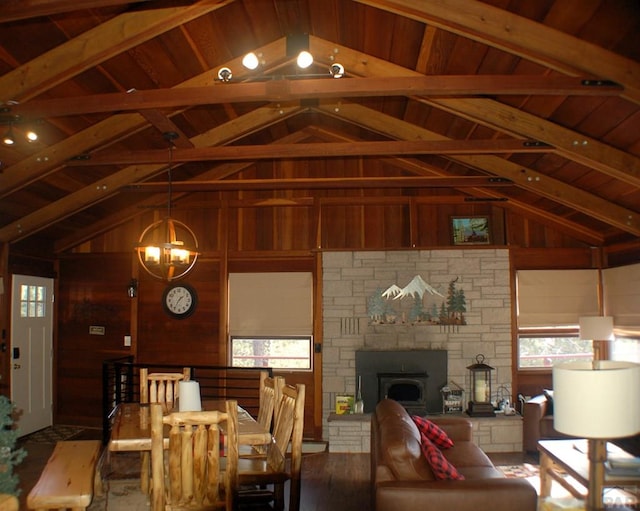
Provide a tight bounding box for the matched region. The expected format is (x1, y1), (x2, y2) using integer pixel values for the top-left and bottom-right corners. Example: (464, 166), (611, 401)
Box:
(517, 270), (600, 328)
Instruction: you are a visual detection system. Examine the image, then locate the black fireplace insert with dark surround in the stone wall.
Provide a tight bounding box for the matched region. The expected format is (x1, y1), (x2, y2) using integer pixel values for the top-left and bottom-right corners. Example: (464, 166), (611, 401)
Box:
(355, 350), (447, 415)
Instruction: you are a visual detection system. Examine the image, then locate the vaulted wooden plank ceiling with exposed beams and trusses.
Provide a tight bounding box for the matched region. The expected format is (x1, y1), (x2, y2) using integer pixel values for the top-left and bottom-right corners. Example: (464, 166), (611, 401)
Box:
(0, 0), (640, 251)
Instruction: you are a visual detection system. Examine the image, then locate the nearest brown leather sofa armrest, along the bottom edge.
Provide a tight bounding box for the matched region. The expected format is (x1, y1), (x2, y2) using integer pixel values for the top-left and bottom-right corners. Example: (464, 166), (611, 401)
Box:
(374, 478), (538, 511)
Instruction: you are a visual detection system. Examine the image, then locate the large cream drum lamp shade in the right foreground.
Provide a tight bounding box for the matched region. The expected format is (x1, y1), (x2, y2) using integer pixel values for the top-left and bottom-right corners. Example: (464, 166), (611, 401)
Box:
(553, 360), (640, 439)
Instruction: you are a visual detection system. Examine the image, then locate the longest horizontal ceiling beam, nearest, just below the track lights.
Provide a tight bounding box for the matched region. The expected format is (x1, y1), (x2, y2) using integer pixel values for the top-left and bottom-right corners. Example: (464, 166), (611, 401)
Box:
(10, 75), (622, 118)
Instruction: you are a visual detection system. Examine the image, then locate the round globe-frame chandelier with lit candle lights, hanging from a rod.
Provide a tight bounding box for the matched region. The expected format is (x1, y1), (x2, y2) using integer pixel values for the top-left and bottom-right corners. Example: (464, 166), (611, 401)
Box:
(136, 132), (198, 282)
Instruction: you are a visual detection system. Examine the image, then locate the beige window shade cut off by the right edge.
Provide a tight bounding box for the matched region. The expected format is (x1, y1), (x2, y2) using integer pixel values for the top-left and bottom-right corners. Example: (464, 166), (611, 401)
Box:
(602, 264), (640, 334)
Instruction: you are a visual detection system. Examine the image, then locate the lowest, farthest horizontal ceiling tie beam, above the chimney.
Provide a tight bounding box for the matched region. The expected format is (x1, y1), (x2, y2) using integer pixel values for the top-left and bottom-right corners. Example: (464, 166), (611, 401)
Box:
(128, 176), (513, 192)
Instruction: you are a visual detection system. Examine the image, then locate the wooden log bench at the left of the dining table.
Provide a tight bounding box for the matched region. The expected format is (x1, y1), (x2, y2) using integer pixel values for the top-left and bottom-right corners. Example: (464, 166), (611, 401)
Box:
(27, 440), (102, 511)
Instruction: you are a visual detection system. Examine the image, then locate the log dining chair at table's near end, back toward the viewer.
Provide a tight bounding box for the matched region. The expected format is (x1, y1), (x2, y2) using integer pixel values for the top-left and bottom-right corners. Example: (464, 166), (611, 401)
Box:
(150, 400), (238, 511)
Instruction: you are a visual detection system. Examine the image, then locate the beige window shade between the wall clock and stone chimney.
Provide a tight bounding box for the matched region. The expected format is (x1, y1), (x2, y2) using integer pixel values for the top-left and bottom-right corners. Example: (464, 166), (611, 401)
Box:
(229, 272), (313, 336)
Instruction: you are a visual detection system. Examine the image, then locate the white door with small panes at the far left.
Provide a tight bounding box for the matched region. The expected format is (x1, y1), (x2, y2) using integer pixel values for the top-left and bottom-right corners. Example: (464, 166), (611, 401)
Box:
(11, 275), (53, 436)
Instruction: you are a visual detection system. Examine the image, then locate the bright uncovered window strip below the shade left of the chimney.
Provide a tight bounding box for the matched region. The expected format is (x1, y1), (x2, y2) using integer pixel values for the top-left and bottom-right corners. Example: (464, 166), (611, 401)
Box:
(231, 336), (312, 371)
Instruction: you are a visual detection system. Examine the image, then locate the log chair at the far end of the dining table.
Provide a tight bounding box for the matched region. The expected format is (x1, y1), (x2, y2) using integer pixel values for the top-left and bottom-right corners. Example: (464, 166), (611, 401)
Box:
(140, 367), (191, 493)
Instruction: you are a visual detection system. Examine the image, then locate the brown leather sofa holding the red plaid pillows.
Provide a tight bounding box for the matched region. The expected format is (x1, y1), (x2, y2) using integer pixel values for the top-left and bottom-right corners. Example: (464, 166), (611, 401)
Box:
(371, 399), (537, 511)
